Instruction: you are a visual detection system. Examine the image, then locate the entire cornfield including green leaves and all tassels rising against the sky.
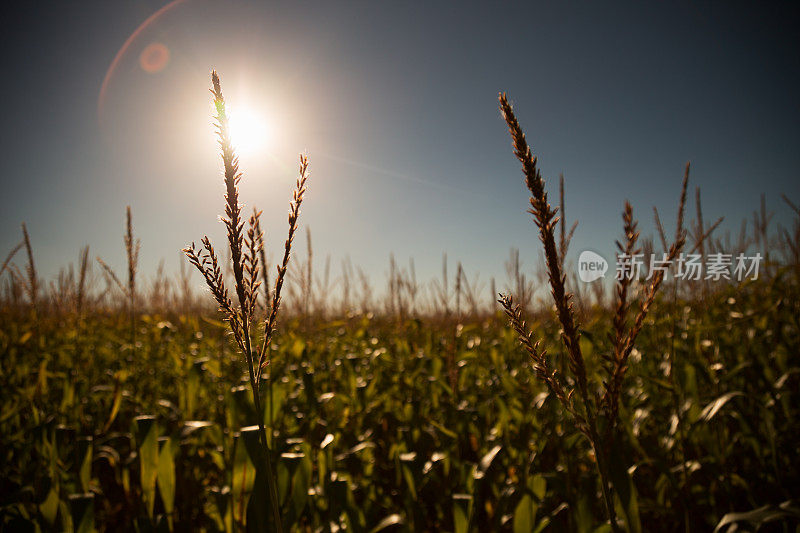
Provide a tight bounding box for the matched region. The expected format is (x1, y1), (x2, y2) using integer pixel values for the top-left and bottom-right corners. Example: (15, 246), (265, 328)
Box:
(0, 74), (800, 533)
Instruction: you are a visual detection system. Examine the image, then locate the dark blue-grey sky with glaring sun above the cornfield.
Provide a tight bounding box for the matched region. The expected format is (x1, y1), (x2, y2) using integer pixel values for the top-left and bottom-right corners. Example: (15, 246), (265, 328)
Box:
(0, 0), (800, 298)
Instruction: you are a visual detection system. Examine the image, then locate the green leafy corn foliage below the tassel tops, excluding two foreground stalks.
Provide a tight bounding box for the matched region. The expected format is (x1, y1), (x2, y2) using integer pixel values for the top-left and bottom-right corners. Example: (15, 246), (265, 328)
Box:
(0, 251), (800, 531)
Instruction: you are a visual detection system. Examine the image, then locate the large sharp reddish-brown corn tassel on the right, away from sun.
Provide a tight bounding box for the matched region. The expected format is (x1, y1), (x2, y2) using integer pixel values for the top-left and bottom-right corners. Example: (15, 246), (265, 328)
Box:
(499, 93), (689, 532)
